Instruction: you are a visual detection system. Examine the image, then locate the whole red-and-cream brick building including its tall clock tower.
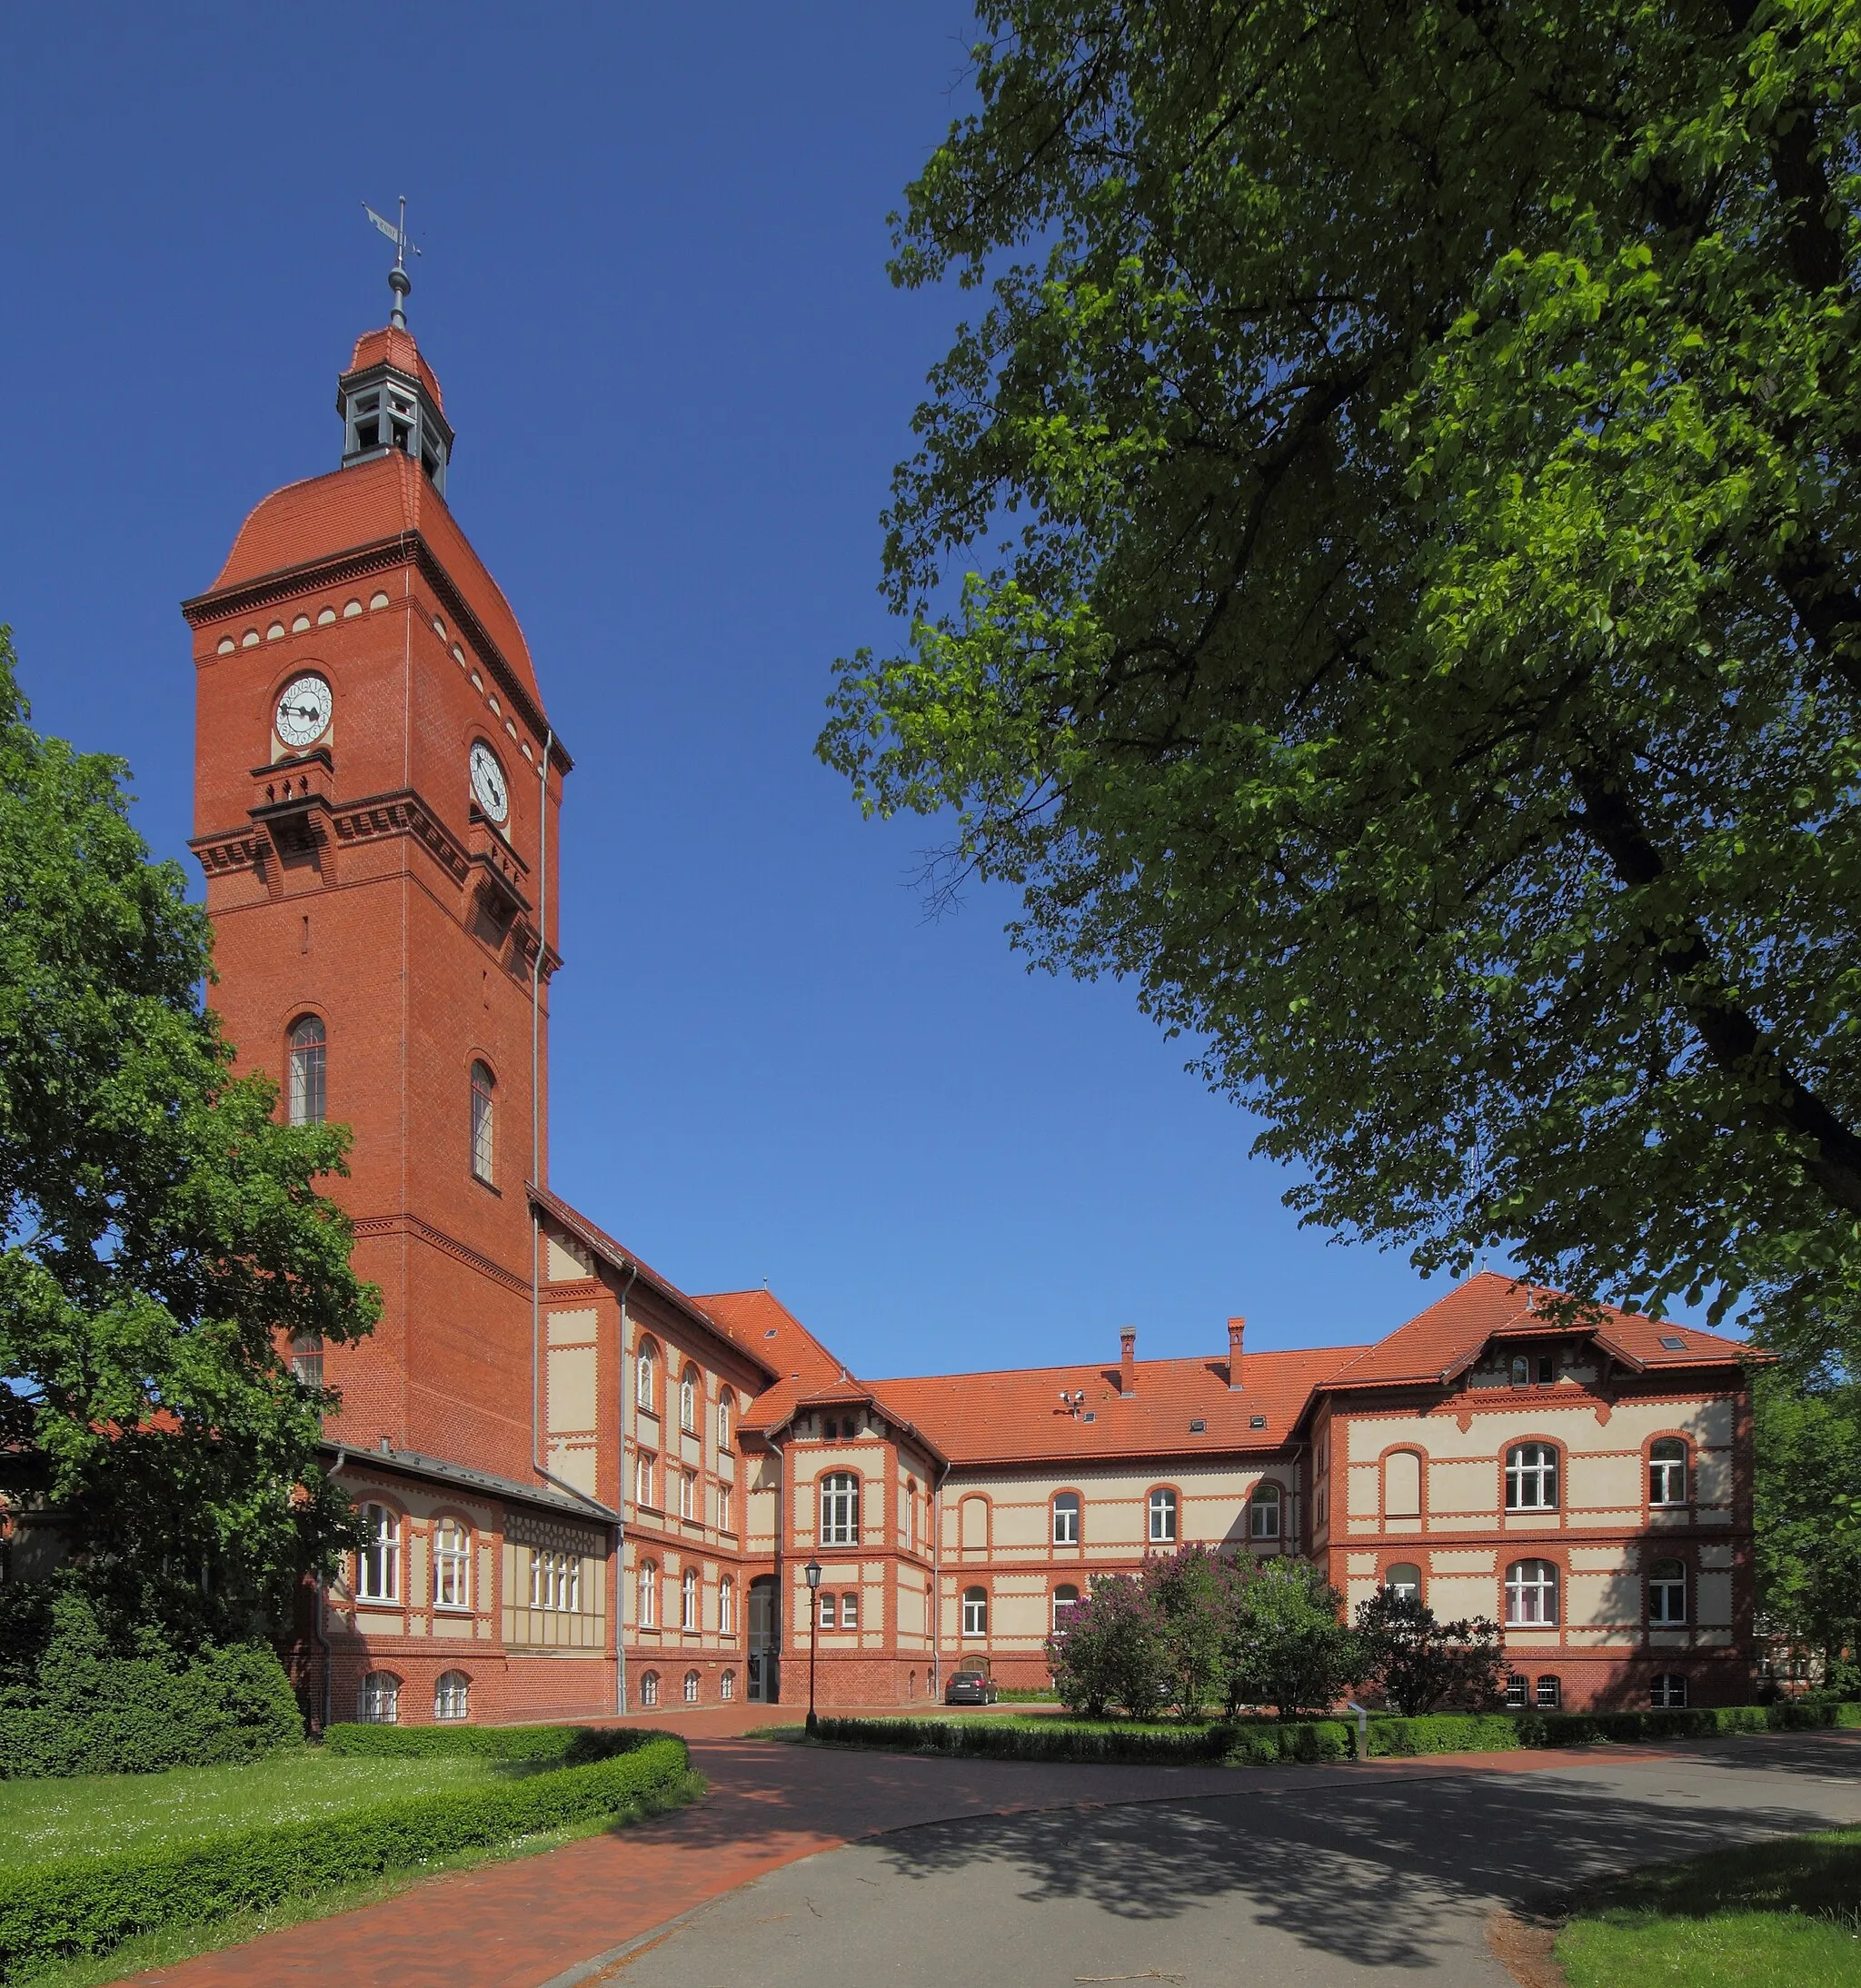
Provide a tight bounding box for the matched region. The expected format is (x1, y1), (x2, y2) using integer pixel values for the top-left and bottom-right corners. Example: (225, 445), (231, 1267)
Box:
(184, 313), (1752, 1722)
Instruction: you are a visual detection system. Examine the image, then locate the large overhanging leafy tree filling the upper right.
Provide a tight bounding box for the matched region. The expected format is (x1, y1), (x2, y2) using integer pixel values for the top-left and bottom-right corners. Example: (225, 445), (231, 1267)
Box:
(821, 0), (1861, 1362)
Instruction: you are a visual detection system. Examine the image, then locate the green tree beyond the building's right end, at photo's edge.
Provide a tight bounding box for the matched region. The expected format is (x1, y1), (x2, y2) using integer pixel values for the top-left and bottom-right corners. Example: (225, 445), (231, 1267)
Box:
(1752, 1372), (1861, 1692)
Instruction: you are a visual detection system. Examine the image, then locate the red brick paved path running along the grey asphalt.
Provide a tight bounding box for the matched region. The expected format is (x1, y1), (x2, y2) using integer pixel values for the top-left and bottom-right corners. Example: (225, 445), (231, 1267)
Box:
(135, 1707), (1741, 1988)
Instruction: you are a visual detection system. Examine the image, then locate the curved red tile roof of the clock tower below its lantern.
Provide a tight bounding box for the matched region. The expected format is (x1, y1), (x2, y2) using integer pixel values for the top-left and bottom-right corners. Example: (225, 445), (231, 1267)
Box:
(202, 449), (542, 710)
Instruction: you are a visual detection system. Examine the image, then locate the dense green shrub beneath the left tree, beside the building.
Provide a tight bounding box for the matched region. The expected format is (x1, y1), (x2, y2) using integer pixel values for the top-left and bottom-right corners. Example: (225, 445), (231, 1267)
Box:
(0, 1595), (304, 1779)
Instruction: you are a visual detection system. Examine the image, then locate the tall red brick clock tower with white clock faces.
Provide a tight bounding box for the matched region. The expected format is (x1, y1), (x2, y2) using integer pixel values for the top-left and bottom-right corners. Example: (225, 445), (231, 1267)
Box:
(184, 305), (569, 1481)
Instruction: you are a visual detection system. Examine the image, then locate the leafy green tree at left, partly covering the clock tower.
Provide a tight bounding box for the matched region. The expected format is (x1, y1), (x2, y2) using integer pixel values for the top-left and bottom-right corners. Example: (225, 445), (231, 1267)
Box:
(0, 631), (376, 1636)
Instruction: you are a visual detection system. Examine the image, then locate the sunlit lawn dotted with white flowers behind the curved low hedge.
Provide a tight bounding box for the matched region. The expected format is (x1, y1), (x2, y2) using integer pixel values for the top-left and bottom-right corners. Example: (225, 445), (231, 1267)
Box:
(0, 1747), (557, 1871)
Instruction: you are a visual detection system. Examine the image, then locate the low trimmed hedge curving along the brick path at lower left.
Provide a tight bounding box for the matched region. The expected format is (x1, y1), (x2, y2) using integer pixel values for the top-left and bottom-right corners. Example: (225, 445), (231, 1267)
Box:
(0, 1727), (690, 1982)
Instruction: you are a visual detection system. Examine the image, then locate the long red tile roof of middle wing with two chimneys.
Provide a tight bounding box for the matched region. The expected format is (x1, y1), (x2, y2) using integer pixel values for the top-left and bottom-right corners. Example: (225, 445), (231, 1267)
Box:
(873, 1346), (1362, 1463)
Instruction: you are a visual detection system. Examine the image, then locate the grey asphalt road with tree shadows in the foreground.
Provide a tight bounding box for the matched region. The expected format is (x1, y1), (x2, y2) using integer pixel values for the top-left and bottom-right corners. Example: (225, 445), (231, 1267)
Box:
(601, 1735), (1861, 1988)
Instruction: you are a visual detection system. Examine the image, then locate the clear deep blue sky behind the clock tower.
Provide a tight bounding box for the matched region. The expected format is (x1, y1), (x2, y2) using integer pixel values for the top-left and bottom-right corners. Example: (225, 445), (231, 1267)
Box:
(0, 0), (1478, 1376)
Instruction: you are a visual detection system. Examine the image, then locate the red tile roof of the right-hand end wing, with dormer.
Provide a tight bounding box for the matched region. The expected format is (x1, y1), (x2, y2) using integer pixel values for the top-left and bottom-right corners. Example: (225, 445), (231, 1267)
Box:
(1324, 1270), (1767, 1389)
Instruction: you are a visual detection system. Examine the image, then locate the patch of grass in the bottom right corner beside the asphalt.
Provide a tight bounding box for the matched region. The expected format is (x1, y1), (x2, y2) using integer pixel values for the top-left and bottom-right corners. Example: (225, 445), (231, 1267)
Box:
(1557, 1829), (1861, 1988)
